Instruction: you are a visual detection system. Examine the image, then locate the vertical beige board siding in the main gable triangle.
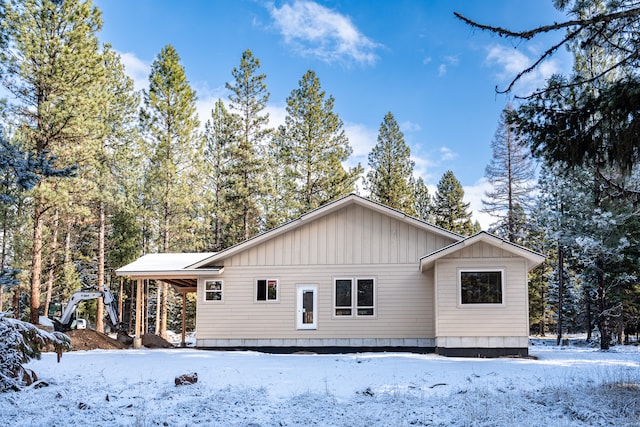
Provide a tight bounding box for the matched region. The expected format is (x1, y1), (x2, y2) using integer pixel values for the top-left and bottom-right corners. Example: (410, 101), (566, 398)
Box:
(222, 204), (455, 268)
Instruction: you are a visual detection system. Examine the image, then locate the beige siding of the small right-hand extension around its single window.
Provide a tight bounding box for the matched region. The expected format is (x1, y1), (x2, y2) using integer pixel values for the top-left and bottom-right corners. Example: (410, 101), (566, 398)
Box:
(434, 258), (529, 346)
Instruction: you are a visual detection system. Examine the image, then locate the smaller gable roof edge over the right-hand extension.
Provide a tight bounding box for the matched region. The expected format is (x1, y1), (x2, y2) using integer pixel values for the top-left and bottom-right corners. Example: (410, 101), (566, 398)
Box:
(420, 231), (545, 271)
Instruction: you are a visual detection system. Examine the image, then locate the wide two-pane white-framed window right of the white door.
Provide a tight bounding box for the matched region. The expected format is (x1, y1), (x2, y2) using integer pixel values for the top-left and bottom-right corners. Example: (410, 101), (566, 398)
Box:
(333, 277), (376, 317)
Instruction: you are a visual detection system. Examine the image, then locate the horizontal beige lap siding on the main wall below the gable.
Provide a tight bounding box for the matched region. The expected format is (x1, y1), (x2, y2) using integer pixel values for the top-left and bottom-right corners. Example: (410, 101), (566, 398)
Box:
(196, 264), (435, 345)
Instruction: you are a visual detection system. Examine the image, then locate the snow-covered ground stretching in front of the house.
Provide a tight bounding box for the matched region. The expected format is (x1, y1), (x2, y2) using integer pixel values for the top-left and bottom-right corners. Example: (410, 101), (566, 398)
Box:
(0, 345), (640, 427)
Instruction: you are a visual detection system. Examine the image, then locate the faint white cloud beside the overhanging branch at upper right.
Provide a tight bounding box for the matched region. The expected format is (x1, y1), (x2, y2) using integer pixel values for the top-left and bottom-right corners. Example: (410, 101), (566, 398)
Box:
(485, 45), (560, 93)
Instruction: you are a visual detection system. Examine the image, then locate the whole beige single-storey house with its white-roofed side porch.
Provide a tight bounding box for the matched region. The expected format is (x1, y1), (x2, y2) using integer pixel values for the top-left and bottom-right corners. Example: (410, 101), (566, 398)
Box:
(116, 194), (544, 356)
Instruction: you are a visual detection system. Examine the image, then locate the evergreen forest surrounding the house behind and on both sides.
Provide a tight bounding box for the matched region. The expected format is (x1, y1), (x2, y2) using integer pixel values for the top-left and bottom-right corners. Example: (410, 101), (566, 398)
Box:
(0, 0), (640, 349)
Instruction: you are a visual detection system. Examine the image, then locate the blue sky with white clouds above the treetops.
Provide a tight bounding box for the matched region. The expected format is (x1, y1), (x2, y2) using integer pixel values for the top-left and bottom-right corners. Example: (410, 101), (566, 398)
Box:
(95, 0), (571, 228)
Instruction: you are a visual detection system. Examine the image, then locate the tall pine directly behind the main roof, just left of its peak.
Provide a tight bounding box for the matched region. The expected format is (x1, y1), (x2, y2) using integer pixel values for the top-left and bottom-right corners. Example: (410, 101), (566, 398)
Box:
(285, 70), (362, 215)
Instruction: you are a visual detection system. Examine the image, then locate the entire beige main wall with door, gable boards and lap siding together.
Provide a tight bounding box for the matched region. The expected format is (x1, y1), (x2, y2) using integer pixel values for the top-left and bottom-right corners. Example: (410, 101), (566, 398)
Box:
(196, 205), (454, 347)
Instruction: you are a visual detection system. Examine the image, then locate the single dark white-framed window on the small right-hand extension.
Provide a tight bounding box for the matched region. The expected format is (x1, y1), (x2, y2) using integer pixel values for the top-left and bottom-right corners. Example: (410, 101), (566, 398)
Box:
(458, 268), (504, 305)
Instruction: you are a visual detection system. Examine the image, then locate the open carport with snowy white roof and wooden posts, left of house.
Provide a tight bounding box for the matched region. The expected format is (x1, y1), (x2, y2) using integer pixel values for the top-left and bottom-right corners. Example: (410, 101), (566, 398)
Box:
(116, 252), (223, 348)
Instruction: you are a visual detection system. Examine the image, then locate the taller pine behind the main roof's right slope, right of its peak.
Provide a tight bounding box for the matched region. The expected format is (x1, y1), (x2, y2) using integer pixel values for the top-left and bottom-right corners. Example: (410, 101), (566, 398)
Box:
(366, 112), (416, 215)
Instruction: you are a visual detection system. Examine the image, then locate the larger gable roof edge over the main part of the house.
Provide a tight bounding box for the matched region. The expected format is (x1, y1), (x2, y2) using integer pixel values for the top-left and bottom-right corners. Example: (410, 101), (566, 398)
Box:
(189, 194), (463, 268)
